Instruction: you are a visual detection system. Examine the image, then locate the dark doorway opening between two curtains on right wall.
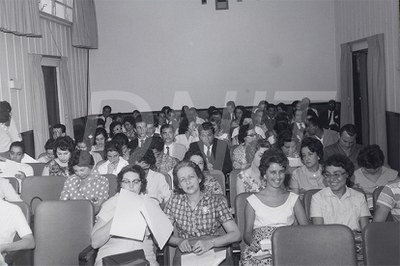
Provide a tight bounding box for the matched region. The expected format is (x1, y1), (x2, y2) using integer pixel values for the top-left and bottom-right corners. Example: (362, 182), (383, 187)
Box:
(352, 49), (369, 145)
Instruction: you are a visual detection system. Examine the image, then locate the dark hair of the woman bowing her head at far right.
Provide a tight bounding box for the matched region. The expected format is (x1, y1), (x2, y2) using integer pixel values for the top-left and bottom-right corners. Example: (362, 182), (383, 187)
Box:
(357, 144), (385, 169)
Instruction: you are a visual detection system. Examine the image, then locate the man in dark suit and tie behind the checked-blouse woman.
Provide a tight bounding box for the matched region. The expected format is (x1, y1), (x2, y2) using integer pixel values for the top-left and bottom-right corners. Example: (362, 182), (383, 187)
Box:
(189, 122), (232, 174)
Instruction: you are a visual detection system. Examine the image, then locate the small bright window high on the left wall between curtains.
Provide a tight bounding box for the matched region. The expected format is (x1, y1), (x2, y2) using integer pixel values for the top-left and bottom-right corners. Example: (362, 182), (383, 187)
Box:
(39, 0), (73, 22)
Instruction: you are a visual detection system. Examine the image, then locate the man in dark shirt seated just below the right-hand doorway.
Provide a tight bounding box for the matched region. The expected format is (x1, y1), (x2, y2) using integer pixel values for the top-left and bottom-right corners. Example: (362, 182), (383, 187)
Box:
(324, 124), (362, 169)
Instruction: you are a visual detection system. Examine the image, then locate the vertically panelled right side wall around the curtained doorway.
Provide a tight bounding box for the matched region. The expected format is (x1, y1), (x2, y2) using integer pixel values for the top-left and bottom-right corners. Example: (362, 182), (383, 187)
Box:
(335, 0), (400, 113)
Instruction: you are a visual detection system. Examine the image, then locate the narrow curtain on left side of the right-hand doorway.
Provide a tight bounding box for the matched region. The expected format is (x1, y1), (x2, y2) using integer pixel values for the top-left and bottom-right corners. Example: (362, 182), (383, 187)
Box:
(340, 43), (354, 126)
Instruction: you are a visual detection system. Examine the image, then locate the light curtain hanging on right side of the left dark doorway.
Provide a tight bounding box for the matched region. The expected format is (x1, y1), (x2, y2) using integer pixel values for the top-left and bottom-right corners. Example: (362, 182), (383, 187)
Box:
(59, 57), (74, 136)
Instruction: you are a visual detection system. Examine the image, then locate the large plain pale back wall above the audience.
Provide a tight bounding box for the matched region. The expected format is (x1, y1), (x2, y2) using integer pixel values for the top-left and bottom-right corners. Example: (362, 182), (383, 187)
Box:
(90, 0), (337, 113)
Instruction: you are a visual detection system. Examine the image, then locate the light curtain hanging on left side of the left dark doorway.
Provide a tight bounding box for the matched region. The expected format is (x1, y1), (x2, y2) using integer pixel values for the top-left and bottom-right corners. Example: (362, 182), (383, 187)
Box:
(26, 54), (49, 158)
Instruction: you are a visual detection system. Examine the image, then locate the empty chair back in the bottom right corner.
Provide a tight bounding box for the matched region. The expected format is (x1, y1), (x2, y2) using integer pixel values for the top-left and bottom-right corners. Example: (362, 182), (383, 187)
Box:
(363, 222), (400, 265)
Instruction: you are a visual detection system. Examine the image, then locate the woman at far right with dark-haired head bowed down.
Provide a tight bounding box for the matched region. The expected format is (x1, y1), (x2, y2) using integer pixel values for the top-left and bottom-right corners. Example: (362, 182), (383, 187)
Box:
(352, 144), (399, 208)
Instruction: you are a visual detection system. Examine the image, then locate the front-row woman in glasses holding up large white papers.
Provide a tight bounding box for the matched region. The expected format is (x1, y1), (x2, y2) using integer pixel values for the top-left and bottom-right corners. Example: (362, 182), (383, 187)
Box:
(92, 165), (158, 266)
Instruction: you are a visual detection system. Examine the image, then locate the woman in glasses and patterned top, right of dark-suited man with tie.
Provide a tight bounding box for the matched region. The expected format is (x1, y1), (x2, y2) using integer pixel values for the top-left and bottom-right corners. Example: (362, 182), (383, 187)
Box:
(232, 125), (257, 169)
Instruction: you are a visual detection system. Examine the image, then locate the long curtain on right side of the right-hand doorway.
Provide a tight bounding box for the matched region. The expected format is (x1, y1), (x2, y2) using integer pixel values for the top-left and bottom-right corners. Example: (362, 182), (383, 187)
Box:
(367, 34), (387, 158)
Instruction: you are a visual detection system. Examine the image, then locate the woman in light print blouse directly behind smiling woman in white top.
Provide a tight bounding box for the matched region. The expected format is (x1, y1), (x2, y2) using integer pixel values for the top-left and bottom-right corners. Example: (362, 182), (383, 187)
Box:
(236, 139), (271, 195)
